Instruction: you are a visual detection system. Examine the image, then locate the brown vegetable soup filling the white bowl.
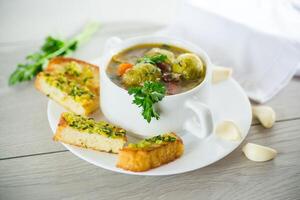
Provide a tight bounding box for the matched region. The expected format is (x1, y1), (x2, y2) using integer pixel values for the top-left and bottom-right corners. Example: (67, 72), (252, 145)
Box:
(106, 44), (205, 95)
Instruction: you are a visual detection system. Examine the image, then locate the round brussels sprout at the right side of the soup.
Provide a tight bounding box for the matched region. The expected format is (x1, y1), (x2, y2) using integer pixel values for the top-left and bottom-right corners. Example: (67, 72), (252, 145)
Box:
(172, 53), (203, 80)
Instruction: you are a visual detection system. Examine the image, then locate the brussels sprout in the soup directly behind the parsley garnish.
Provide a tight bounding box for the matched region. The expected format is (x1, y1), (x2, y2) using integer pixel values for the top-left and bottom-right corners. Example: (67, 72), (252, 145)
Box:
(122, 63), (161, 86)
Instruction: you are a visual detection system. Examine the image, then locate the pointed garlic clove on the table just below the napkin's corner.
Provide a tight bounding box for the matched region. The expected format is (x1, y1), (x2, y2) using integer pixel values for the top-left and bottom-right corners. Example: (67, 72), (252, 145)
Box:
(252, 106), (276, 128)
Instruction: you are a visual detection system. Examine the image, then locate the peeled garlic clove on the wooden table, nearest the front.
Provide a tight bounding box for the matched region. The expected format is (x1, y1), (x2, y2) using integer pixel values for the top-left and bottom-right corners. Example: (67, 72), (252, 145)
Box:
(243, 143), (277, 162)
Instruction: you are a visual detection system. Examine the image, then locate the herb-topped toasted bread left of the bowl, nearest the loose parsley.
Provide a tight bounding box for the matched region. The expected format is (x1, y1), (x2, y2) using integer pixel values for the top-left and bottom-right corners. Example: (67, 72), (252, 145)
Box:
(35, 57), (99, 115)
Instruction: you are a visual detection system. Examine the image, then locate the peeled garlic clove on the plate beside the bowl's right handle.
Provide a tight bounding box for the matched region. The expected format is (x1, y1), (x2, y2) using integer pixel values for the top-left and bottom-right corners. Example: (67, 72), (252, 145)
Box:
(215, 121), (242, 141)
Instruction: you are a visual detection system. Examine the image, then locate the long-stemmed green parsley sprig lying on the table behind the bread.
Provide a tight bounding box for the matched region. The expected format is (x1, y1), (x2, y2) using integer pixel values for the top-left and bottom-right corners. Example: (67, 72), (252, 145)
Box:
(8, 23), (98, 85)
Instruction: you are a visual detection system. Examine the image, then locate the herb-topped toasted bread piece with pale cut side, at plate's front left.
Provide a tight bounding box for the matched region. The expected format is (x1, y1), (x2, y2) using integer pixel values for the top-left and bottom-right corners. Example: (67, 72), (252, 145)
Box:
(53, 112), (127, 153)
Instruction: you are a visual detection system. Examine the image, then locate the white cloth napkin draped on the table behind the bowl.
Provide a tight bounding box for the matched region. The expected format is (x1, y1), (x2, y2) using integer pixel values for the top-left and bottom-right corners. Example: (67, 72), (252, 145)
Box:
(160, 0), (300, 103)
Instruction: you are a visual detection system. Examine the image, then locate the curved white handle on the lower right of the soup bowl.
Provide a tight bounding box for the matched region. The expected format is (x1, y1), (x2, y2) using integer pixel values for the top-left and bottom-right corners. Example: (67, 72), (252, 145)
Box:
(184, 100), (214, 139)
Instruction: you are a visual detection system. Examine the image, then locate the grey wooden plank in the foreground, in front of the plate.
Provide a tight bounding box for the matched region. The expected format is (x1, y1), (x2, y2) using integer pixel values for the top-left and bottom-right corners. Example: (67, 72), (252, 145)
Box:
(0, 120), (300, 200)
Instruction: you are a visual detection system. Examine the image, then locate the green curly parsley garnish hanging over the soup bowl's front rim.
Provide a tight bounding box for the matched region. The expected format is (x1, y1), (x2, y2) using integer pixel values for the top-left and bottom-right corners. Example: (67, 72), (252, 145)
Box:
(128, 81), (166, 123)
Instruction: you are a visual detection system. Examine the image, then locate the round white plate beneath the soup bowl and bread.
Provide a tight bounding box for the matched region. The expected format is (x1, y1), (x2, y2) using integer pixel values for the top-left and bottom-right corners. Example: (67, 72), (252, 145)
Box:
(48, 74), (252, 176)
